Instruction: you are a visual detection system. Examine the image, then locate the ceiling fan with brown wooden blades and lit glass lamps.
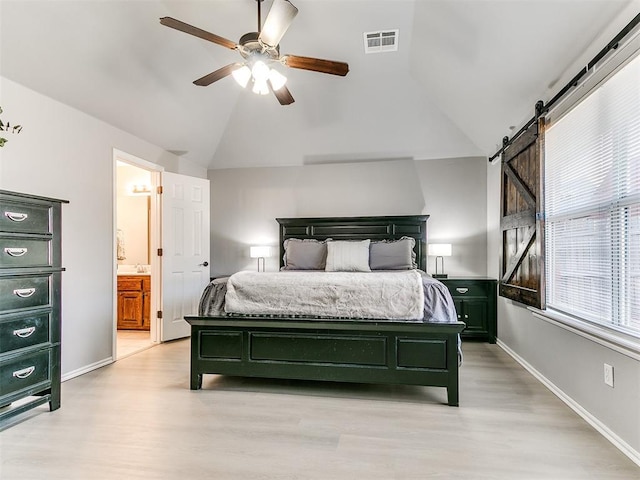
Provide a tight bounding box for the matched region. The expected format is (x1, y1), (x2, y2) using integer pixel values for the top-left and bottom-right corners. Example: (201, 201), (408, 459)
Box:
(160, 0), (349, 105)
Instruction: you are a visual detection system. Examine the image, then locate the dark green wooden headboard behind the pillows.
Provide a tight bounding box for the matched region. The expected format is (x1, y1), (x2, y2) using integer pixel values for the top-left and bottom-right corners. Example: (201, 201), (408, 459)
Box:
(276, 215), (429, 272)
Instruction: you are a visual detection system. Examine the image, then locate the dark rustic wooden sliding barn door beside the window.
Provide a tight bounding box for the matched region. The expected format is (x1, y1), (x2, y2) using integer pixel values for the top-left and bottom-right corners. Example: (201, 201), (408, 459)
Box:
(499, 118), (545, 308)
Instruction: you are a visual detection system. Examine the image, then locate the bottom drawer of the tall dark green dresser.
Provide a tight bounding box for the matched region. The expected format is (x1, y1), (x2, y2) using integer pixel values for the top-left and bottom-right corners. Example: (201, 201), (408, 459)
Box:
(0, 349), (51, 397)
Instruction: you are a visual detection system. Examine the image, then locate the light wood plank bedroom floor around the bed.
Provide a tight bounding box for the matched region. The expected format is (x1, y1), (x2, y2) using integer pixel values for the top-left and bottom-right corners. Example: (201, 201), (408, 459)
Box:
(0, 340), (640, 480)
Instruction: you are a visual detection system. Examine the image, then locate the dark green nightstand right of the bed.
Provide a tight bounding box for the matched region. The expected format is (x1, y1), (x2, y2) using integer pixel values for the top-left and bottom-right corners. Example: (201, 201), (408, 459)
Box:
(438, 277), (498, 343)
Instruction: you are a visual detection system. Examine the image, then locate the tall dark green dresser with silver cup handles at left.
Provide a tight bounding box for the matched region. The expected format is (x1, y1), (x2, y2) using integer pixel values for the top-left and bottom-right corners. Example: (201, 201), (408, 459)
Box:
(0, 190), (67, 421)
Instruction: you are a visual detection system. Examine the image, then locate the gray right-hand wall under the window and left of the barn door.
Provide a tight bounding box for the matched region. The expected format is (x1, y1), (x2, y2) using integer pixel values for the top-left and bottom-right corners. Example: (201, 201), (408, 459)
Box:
(487, 161), (640, 459)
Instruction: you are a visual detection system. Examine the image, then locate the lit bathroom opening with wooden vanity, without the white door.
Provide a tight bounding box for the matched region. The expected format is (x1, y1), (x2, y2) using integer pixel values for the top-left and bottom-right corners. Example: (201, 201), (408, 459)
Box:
(113, 150), (161, 360)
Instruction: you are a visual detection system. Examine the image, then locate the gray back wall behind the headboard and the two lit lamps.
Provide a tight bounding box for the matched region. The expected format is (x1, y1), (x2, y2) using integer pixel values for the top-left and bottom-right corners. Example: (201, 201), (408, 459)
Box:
(209, 157), (487, 276)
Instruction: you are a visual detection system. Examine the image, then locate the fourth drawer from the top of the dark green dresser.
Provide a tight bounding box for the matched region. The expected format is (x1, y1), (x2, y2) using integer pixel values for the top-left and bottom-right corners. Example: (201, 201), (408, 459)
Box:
(0, 312), (51, 354)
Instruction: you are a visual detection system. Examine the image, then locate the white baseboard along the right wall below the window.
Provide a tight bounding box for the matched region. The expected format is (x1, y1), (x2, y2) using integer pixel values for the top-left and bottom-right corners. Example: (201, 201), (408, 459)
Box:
(496, 339), (640, 466)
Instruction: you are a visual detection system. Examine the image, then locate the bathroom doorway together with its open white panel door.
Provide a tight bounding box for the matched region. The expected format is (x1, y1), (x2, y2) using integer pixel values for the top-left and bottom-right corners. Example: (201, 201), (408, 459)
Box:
(112, 149), (211, 360)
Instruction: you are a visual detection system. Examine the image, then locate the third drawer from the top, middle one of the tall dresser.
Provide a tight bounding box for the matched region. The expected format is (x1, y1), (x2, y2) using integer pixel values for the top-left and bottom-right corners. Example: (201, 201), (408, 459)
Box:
(0, 275), (51, 311)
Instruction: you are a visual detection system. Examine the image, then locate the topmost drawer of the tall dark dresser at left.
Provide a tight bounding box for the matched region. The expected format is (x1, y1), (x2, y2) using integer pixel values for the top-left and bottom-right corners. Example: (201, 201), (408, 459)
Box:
(0, 199), (51, 233)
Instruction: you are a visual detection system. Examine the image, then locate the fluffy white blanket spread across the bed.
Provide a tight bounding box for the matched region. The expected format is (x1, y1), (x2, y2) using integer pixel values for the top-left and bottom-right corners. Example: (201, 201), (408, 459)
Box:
(224, 270), (424, 320)
